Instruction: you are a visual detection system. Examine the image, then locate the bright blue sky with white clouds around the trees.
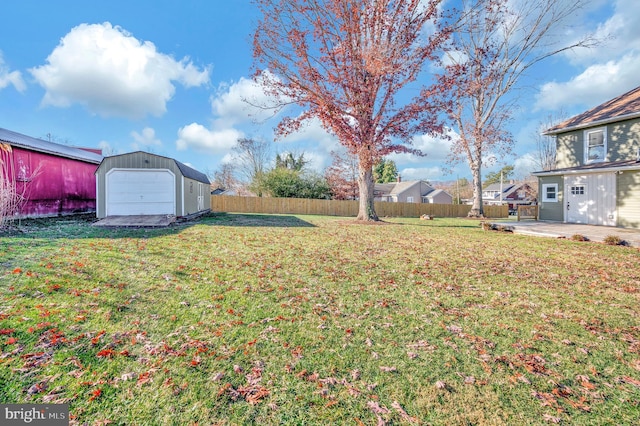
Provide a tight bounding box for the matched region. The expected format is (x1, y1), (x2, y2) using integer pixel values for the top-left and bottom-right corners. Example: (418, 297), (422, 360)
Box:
(0, 0), (640, 181)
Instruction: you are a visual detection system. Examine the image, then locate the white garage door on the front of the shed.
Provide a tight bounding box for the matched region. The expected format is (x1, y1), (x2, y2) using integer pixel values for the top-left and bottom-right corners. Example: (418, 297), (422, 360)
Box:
(105, 169), (176, 216)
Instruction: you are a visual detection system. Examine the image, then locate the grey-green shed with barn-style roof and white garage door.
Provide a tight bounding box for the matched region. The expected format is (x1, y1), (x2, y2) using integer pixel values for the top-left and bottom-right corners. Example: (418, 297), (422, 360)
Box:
(96, 151), (211, 219)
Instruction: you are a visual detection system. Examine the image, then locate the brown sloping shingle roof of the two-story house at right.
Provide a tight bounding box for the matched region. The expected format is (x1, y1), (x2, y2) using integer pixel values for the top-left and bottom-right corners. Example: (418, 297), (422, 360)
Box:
(544, 87), (640, 135)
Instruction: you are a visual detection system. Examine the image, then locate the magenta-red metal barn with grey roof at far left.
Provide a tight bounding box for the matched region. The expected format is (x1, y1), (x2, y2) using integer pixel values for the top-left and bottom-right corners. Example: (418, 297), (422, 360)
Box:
(0, 128), (103, 217)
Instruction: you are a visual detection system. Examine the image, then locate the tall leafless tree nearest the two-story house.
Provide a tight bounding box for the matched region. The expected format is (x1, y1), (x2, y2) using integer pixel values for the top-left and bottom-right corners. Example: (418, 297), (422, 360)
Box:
(442, 0), (597, 217)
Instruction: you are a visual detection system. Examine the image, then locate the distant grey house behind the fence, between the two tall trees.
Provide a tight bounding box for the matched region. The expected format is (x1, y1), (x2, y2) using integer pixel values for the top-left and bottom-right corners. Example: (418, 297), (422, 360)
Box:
(373, 180), (453, 204)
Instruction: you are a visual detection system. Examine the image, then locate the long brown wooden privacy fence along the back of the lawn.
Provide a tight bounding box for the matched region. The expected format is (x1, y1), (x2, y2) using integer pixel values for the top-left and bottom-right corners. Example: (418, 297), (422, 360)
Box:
(211, 195), (509, 218)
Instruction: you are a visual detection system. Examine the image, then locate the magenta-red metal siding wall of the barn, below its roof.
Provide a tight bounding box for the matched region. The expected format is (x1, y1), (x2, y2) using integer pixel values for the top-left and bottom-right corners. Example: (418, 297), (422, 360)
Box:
(4, 147), (98, 216)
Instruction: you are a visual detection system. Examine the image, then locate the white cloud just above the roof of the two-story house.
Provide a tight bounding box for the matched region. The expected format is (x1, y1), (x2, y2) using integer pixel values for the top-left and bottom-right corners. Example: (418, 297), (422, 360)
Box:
(535, 52), (640, 110)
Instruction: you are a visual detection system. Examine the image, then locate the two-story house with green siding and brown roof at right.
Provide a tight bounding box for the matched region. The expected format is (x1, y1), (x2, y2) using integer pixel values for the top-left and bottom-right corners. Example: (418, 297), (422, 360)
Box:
(534, 87), (640, 228)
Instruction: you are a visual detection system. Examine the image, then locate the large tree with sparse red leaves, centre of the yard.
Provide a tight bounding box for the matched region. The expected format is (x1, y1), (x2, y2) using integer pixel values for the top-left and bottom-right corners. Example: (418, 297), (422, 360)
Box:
(254, 0), (447, 221)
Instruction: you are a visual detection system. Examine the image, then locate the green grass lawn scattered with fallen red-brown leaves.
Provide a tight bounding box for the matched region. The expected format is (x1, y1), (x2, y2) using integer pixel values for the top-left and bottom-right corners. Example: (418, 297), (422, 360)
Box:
(0, 214), (640, 425)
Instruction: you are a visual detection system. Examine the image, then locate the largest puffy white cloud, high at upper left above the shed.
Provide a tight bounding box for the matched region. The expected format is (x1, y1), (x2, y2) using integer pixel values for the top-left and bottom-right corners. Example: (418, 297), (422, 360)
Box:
(30, 22), (209, 118)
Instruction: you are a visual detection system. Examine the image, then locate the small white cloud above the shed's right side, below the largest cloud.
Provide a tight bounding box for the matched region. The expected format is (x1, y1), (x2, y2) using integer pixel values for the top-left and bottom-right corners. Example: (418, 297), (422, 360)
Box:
(176, 123), (244, 154)
